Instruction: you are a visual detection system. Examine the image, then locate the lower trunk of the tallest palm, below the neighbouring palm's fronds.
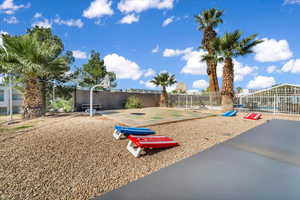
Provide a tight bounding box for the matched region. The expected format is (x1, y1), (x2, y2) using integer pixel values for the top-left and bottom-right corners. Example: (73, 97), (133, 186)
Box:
(207, 62), (221, 106)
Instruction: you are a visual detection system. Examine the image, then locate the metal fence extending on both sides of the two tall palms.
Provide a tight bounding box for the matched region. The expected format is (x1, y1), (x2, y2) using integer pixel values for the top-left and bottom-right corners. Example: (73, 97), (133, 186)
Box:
(169, 87), (300, 115)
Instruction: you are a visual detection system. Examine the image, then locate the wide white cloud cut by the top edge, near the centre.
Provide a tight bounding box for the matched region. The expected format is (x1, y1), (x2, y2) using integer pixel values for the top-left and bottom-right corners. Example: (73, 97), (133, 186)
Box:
(118, 0), (174, 13)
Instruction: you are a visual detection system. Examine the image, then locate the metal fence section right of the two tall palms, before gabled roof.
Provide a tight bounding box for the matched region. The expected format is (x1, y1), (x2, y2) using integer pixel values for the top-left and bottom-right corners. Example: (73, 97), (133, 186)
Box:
(234, 87), (300, 115)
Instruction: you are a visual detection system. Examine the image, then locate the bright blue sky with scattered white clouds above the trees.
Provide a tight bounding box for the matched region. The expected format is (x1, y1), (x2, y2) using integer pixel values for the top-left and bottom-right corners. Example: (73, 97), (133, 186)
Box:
(0, 0), (300, 90)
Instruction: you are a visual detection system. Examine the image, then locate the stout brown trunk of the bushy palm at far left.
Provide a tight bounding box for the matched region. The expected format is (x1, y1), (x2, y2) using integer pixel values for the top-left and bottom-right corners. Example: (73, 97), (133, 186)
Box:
(23, 78), (42, 119)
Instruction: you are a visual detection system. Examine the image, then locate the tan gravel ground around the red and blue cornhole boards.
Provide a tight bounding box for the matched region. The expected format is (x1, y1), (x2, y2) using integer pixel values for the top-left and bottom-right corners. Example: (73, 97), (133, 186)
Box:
(0, 115), (297, 200)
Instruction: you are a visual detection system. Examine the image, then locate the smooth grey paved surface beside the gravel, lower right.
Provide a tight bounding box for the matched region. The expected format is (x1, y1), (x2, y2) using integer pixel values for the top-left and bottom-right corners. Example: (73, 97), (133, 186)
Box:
(95, 120), (300, 200)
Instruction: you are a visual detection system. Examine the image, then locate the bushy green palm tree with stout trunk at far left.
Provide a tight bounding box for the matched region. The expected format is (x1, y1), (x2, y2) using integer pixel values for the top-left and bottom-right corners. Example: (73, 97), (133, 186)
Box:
(0, 27), (69, 119)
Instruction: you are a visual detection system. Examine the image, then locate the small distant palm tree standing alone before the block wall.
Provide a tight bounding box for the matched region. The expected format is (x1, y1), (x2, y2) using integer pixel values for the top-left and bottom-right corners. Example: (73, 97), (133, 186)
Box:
(151, 73), (177, 107)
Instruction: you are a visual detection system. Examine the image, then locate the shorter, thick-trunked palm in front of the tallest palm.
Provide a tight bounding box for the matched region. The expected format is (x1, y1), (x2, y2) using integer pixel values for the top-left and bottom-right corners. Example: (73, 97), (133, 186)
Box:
(211, 30), (263, 110)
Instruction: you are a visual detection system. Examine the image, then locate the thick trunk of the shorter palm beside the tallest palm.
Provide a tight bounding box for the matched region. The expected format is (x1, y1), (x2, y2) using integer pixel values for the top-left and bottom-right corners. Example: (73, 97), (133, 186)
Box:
(221, 58), (234, 111)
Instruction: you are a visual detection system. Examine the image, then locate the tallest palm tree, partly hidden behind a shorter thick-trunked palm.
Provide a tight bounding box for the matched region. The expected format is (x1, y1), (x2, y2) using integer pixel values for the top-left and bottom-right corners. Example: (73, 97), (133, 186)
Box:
(195, 8), (223, 105)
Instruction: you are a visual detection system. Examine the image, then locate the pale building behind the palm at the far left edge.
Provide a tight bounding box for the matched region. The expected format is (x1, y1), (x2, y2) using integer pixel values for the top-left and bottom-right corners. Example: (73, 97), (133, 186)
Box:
(0, 86), (23, 115)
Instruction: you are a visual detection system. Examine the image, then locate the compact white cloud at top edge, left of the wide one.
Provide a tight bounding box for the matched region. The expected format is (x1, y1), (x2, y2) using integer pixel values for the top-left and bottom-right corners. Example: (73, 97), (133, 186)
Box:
(82, 0), (114, 19)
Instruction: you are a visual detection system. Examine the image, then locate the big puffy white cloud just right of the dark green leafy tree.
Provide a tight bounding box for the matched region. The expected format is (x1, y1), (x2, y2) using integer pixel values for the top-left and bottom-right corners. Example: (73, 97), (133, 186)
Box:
(104, 53), (143, 80)
